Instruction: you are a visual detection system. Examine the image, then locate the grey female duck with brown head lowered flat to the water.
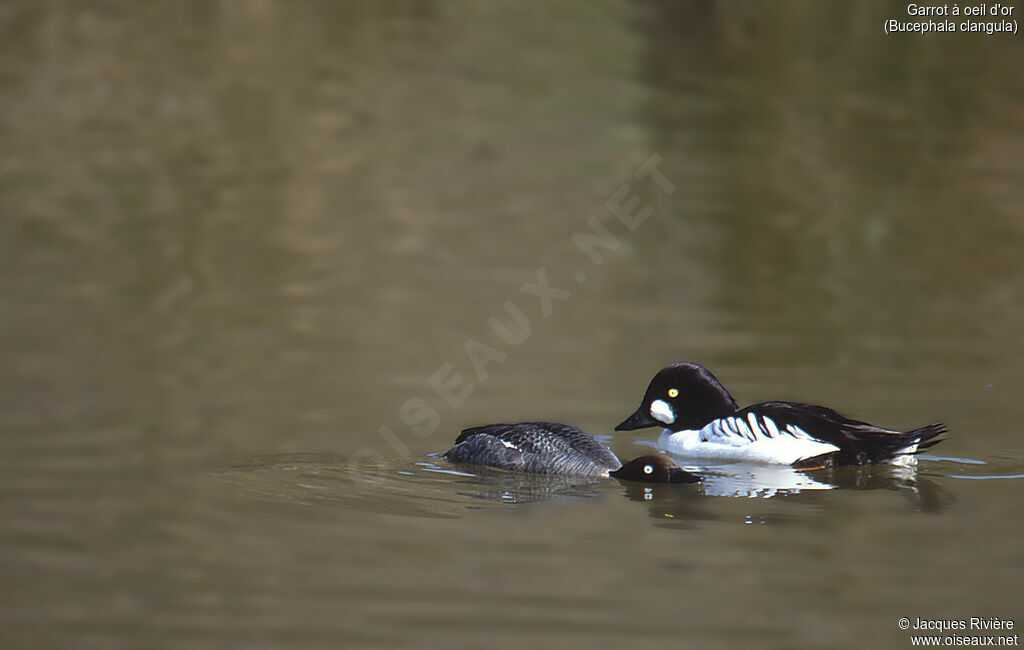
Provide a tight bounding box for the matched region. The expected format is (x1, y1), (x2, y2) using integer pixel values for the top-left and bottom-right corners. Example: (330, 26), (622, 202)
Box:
(444, 422), (700, 483)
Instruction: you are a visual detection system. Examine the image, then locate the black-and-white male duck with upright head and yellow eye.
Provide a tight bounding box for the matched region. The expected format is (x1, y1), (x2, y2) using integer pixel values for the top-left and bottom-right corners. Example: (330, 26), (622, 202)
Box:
(615, 362), (946, 469)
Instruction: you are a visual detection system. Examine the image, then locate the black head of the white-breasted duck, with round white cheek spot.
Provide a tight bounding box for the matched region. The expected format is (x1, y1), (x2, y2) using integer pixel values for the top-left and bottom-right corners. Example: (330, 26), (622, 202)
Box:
(615, 363), (736, 431)
